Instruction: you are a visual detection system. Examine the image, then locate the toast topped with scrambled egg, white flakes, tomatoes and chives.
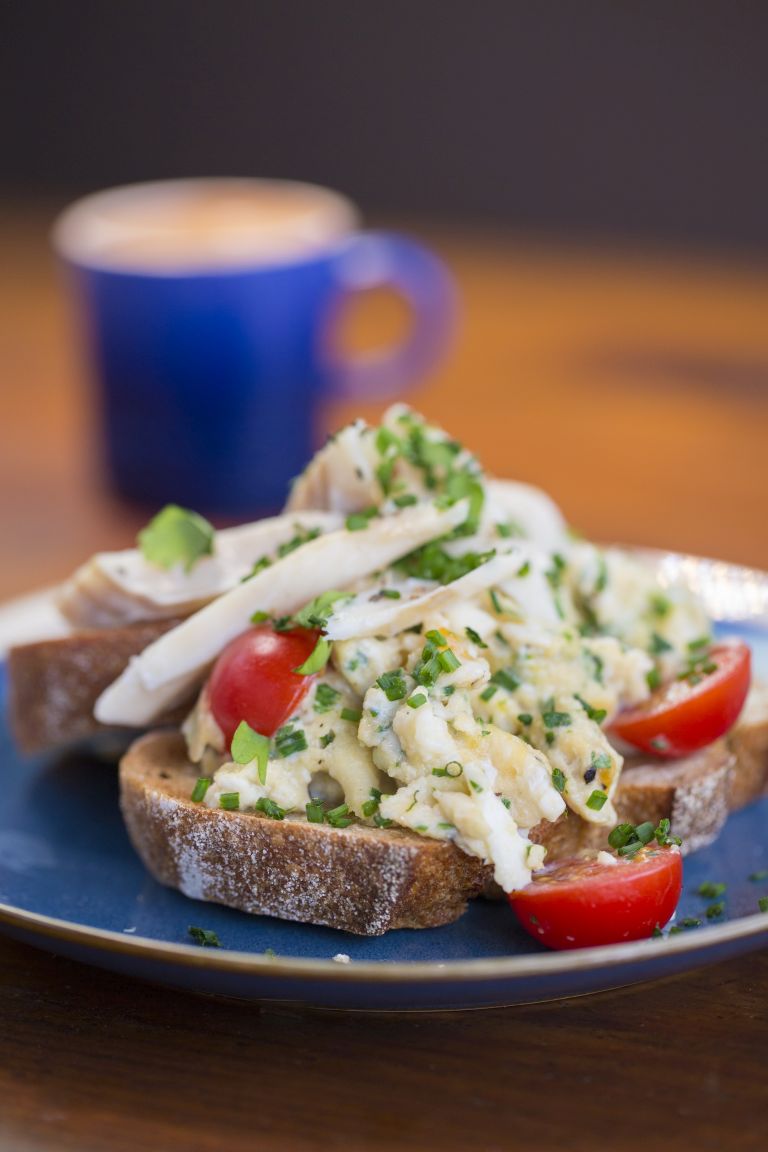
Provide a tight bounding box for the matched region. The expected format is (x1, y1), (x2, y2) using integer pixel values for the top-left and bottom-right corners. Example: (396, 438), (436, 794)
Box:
(6, 407), (768, 933)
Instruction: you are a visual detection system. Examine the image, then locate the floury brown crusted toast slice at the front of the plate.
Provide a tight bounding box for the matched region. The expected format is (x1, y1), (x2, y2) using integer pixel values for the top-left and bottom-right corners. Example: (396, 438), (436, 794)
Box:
(120, 733), (487, 935)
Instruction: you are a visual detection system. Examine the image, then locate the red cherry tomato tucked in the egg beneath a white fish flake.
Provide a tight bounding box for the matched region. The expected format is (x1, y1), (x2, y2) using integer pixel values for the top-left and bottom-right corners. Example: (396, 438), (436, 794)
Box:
(206, 624), (319, 748)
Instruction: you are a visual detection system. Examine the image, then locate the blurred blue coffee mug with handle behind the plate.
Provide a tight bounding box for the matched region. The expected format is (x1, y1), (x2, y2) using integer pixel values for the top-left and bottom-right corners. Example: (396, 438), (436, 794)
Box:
(54, 180), (455, 517)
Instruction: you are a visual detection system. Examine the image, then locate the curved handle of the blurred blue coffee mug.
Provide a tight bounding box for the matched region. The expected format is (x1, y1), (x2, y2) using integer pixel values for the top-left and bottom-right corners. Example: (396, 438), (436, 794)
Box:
(329, 232), (457, 400)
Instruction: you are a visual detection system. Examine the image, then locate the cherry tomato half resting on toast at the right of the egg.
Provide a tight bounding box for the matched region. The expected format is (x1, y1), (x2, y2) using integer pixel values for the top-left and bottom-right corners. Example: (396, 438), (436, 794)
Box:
(611, 641), (751, 756)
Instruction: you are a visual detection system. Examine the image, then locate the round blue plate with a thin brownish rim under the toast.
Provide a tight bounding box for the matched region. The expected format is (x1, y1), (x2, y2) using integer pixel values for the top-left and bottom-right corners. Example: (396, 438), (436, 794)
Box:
(0, 555), (768, 1010)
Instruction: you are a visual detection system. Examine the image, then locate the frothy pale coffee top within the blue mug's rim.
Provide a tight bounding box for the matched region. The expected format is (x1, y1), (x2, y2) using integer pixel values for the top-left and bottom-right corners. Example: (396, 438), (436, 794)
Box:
(53, 180), (357, 274)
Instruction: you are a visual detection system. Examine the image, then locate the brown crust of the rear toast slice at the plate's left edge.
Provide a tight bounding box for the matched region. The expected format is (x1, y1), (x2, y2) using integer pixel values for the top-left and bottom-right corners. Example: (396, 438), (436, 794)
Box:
(8, 619), (188, 753)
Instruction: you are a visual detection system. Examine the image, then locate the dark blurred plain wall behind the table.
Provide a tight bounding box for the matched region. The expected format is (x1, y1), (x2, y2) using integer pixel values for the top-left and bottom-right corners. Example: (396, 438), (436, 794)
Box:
(0, 0), (768, 255)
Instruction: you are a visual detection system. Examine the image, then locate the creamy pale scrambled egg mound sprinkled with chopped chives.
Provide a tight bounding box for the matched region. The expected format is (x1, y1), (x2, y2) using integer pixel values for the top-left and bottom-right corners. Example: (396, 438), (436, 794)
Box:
(185, 409), (708, 892)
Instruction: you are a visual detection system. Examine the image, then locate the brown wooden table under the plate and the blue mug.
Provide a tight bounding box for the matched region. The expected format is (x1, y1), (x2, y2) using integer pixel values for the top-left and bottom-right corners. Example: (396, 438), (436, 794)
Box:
(0, 204), (768, 1152)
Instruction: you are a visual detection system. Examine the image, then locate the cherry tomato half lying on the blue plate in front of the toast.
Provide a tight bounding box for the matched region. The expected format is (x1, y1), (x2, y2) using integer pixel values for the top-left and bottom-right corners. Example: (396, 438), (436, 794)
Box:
(509, 846), (683, 948)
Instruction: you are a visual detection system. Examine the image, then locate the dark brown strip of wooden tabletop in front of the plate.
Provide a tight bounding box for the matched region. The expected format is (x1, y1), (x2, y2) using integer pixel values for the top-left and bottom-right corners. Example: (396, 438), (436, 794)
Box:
(0, 942), (768, 1152)
